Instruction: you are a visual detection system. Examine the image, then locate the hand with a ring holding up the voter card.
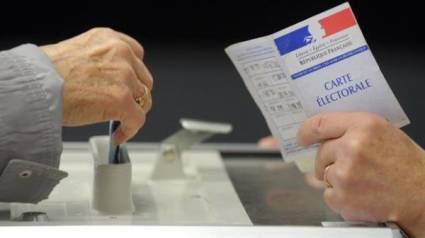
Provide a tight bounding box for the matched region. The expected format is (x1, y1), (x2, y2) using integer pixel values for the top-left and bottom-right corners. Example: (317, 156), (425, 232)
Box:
(298, 113), (425, 237)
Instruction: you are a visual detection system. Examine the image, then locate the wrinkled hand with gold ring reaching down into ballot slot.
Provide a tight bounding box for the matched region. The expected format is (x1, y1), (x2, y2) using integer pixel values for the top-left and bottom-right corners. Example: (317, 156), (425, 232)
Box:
(41, 28), (153, 144)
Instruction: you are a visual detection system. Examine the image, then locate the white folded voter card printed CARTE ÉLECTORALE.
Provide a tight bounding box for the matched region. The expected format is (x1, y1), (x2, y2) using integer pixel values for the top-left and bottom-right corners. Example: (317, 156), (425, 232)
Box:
(226, 3), (409, 164)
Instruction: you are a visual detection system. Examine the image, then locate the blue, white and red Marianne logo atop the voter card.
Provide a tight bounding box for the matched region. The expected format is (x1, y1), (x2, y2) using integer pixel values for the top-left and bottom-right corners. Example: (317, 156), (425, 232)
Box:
(274, 8), (357, 55)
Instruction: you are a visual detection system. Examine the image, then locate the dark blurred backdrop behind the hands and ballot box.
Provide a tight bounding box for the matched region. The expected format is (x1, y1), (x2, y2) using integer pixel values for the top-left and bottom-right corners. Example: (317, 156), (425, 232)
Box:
(0, 0), (425, 146)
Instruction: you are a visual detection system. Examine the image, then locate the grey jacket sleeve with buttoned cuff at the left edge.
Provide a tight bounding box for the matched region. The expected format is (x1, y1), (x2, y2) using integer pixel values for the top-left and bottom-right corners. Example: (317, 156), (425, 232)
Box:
(0, 44), (67, 203)
